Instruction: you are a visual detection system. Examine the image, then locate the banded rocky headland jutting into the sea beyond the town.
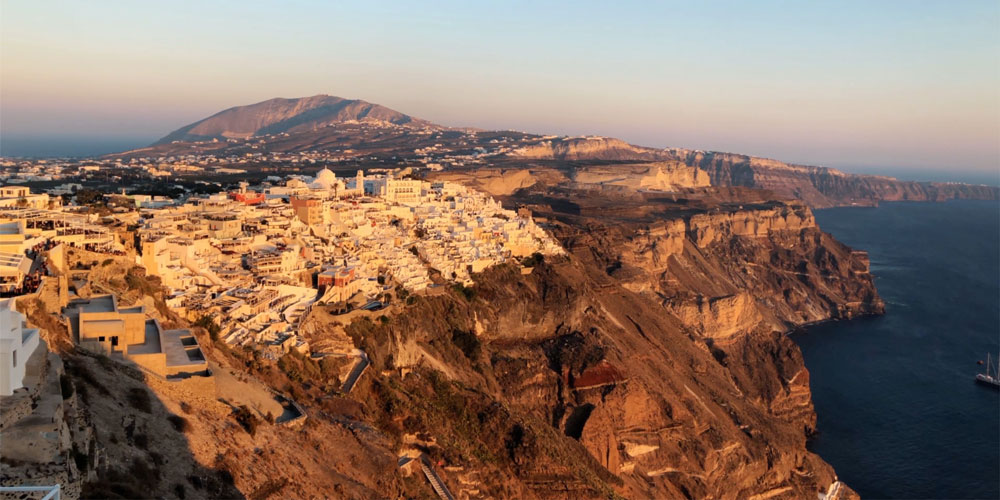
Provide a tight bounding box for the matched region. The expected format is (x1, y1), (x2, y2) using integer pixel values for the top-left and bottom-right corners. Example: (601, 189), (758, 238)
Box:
(592, 199), (882, 332)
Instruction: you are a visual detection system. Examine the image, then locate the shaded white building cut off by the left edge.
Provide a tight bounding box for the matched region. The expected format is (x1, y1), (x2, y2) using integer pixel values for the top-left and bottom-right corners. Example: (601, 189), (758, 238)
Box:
(0, 299), (39, 396)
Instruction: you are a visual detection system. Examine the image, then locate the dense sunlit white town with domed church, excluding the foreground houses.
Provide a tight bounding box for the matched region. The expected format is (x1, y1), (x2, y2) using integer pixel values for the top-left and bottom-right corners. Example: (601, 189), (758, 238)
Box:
(0, 164), (563, 376)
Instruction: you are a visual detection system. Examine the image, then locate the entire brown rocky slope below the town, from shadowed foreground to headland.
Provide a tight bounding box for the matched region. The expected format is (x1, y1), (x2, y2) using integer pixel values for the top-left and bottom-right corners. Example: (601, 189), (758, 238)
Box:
(11, 179), (881, 499)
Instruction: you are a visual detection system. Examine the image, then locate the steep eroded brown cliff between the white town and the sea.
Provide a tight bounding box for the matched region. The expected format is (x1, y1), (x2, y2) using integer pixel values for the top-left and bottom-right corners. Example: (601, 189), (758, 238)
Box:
(322, 182), (882, 498)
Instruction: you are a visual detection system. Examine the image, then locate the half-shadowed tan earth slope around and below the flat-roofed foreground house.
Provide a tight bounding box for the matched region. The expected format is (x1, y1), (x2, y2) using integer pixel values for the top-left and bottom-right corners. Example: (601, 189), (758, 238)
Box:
(17, 250), (413, 499)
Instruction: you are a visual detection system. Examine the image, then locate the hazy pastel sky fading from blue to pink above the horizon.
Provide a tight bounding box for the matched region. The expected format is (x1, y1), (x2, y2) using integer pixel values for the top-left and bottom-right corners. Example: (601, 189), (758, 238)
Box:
(0, 0), (1000, 183)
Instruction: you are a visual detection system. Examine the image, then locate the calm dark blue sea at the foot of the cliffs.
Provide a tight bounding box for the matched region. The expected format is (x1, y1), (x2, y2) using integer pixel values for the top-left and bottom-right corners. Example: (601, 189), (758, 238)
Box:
(792, 201), (1000, 499)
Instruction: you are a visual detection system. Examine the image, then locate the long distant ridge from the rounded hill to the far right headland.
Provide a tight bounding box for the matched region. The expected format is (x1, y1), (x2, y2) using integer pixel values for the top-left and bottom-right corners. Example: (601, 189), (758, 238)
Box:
(127, 95), (1000, 208)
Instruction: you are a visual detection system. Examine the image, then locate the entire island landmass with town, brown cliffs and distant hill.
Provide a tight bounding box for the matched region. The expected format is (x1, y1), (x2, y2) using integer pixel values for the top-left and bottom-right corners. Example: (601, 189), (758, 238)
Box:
(0, 96), (928, 500)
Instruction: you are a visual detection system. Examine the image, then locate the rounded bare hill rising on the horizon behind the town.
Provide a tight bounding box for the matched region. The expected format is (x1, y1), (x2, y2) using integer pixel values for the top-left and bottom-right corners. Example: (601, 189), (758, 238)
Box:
(153, 95), (440, 145)
